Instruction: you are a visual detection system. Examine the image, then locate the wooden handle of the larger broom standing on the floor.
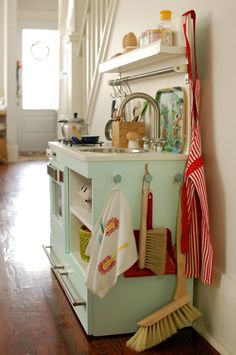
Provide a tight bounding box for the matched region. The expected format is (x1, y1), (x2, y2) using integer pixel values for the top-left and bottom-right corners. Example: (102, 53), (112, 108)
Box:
(174, 195), (188, 300)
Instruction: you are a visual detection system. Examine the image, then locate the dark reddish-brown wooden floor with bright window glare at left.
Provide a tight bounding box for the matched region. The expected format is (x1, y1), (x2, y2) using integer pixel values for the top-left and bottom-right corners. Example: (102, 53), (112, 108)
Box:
(0, 160), (218, 355)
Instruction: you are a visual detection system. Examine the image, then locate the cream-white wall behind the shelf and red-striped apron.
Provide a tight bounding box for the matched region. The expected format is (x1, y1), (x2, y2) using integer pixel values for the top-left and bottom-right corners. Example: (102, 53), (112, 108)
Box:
(91, 0), (236, 354)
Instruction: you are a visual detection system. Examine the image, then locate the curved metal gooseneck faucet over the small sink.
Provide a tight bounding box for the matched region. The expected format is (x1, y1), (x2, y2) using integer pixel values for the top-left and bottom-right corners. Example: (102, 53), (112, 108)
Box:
(117, 92), (161, 150)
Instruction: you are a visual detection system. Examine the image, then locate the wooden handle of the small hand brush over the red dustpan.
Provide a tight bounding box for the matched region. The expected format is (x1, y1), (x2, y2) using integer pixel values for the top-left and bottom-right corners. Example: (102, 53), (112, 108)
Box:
(138, 179), (149, 270)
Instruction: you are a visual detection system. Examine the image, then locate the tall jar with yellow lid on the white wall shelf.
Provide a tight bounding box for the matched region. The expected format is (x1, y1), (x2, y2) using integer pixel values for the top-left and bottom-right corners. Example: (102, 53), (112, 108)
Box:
(158, 10), (173, 46)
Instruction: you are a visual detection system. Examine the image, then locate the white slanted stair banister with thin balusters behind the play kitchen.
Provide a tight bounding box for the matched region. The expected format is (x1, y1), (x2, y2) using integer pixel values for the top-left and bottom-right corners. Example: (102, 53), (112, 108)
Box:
(79, 0), (117, 123)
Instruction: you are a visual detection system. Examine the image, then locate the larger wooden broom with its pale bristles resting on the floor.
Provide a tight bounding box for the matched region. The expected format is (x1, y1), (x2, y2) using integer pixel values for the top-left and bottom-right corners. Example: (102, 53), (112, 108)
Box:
(126, 199), (201, 351)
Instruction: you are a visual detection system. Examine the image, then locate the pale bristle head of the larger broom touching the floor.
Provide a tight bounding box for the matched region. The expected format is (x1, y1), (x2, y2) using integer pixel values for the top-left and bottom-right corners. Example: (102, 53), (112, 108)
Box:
(126, 303), (201, 352)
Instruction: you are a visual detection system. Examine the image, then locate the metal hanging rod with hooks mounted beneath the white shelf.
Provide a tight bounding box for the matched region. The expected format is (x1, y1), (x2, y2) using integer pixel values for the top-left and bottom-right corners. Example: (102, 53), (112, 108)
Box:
(108, 64), (188, 86)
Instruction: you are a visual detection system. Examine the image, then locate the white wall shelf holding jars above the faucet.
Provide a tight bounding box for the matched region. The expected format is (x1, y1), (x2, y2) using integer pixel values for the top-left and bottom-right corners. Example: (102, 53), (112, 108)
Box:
(99, 41), (186, 73)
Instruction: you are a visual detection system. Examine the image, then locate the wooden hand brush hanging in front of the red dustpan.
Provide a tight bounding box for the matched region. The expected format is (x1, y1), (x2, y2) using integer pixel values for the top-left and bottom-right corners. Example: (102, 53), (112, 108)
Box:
(138, 164), (168, 275)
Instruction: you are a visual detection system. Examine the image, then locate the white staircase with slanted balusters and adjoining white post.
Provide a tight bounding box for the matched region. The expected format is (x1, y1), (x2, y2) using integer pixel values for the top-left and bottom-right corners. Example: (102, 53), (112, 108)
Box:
(59, 0), (118, 128)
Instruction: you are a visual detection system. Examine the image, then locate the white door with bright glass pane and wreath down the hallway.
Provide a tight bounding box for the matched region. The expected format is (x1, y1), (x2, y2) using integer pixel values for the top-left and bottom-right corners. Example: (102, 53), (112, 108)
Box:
(16, 21), (59, 153)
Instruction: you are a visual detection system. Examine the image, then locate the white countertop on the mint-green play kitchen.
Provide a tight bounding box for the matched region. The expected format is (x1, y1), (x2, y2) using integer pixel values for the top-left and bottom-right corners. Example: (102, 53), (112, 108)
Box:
(48, 142), (188, 161)
